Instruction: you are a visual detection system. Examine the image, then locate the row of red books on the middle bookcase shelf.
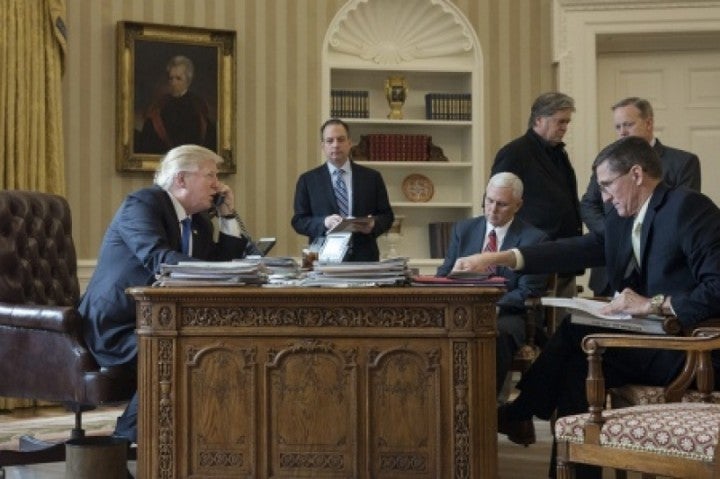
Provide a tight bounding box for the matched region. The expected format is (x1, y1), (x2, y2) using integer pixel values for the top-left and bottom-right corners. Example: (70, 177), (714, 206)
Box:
(351, 133), (448, 161)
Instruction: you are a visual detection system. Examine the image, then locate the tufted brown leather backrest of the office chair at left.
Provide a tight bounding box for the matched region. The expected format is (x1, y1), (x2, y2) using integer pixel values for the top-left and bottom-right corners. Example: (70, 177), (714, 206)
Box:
(0, 190), (80, 306)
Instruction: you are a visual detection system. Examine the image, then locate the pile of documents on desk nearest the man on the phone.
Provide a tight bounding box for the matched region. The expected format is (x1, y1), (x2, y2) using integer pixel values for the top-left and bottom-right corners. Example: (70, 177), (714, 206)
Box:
(154, 260), (268, 286)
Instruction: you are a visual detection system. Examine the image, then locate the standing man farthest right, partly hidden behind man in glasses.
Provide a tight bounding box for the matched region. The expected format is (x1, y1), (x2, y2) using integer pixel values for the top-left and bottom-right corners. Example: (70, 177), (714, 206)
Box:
(580, 97), (700, 296)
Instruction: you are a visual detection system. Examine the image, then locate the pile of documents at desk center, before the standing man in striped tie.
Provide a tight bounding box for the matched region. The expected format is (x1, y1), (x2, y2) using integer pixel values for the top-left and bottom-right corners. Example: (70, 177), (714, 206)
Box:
(300, 258), (410, 288)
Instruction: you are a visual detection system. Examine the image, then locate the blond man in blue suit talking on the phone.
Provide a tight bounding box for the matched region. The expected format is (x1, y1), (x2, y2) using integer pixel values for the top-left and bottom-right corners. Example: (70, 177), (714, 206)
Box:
(78, 145), (259, 442)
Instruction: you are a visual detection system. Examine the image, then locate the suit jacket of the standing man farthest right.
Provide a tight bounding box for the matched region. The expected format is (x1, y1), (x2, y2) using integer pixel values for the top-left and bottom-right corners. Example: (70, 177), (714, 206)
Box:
(580, 139), (700, 294)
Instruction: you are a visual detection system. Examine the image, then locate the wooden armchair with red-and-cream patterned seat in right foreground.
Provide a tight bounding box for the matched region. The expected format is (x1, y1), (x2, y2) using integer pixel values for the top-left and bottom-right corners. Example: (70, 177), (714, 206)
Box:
(555, 328), (720, 479)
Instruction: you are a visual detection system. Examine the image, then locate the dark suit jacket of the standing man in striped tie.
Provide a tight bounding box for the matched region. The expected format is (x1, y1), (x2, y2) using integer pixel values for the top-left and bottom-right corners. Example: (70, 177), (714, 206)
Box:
(291, 162), (395, 261)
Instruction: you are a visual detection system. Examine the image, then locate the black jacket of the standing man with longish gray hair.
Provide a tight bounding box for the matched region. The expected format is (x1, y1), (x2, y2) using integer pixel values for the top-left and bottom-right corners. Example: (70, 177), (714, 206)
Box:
(492, 129), (582, 239)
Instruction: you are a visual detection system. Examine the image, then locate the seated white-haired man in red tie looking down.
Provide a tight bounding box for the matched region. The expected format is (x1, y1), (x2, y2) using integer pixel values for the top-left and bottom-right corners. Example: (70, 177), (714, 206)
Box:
(437, 172), (547, 398)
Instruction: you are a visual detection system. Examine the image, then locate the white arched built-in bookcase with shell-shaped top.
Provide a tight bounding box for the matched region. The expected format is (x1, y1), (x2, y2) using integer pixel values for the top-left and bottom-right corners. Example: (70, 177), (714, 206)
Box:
(322, 0), (485, 273)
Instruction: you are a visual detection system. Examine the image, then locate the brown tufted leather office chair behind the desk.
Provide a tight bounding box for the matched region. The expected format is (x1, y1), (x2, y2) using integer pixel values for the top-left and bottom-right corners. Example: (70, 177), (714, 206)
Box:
(0, 191), (135, 476)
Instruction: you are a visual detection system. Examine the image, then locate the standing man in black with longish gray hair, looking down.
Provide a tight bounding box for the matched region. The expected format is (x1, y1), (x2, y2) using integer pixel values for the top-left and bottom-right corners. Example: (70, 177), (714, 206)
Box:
(492, 92), (582, 317)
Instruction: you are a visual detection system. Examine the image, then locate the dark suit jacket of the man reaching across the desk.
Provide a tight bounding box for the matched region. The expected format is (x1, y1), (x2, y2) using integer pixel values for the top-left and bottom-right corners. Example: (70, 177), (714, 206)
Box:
(520, 183), (720, 329)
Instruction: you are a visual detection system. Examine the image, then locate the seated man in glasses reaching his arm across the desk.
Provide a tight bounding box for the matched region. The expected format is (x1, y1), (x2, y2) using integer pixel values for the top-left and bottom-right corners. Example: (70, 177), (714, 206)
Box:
(455, 136), (720, 479)
